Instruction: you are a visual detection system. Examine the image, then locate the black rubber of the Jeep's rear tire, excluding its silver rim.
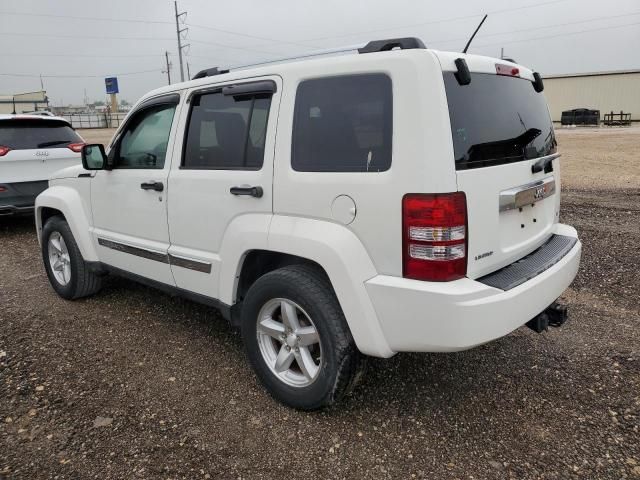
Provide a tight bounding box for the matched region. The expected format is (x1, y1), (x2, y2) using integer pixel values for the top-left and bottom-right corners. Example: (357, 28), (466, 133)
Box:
(241, 265), (364, 410)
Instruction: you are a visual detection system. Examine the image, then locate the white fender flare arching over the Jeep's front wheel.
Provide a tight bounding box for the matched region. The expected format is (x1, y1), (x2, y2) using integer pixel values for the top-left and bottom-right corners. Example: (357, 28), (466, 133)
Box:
(36, 185), (98, 262)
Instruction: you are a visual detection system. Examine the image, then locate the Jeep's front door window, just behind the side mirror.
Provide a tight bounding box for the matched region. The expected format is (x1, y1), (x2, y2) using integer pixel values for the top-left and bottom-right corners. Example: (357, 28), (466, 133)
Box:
(114, 105), (176, 169)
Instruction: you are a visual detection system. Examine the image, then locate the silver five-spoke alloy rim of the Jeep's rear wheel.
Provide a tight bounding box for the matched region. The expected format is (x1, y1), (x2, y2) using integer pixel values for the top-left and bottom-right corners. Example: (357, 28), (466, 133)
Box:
(256, 298), (323, 387)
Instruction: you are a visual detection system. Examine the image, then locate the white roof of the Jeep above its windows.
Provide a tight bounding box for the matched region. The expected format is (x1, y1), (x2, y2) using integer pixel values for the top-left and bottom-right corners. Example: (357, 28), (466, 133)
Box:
(140, 39), (533, 107)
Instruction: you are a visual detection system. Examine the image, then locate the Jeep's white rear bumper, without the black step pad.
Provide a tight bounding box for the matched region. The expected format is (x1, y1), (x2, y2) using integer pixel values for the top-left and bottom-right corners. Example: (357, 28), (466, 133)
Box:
(365, 224), (582, 352)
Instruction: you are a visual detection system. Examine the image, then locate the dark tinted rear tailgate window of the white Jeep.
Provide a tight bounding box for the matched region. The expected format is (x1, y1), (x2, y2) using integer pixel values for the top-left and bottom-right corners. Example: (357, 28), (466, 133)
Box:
(444, 72), (556, 170)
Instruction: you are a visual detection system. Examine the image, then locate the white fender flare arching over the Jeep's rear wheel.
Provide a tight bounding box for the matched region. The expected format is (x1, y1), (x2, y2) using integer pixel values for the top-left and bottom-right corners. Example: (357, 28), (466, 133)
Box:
(220, 215), (395, 357)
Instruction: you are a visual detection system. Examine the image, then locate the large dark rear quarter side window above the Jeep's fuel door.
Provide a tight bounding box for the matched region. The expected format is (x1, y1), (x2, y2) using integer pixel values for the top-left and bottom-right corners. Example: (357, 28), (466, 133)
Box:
(291, 74), (393, 172)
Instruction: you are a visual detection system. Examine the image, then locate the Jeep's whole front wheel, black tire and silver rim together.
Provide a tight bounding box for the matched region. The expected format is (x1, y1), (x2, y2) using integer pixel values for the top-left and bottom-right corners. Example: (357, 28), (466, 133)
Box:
(42, 216), (102, 300)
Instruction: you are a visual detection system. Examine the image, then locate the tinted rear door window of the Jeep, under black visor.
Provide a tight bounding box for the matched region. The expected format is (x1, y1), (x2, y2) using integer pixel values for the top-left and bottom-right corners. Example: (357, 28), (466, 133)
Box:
(182, 92), (271, 170)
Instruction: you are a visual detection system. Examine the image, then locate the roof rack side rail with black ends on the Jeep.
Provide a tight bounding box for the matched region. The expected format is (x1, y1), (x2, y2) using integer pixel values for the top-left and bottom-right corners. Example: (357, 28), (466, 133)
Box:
(191, 37), (427, 80)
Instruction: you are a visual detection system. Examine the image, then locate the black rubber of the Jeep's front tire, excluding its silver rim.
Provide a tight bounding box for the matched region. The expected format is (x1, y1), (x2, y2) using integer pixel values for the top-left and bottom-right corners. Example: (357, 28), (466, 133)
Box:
(41, 216), (102, 300)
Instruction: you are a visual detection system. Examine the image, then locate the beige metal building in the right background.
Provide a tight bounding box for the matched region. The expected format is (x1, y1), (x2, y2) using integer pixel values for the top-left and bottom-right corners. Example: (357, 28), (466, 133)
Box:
(544, 70), (640, 122)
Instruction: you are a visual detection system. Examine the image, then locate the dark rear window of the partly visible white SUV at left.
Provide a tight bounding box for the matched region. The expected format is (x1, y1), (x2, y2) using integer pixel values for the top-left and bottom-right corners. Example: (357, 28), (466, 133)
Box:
(0, 119), (83, 150)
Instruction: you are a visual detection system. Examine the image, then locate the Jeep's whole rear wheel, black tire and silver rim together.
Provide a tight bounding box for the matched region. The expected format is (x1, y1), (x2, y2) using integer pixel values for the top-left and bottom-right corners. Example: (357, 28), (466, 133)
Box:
(241, 265), (364, 410)
